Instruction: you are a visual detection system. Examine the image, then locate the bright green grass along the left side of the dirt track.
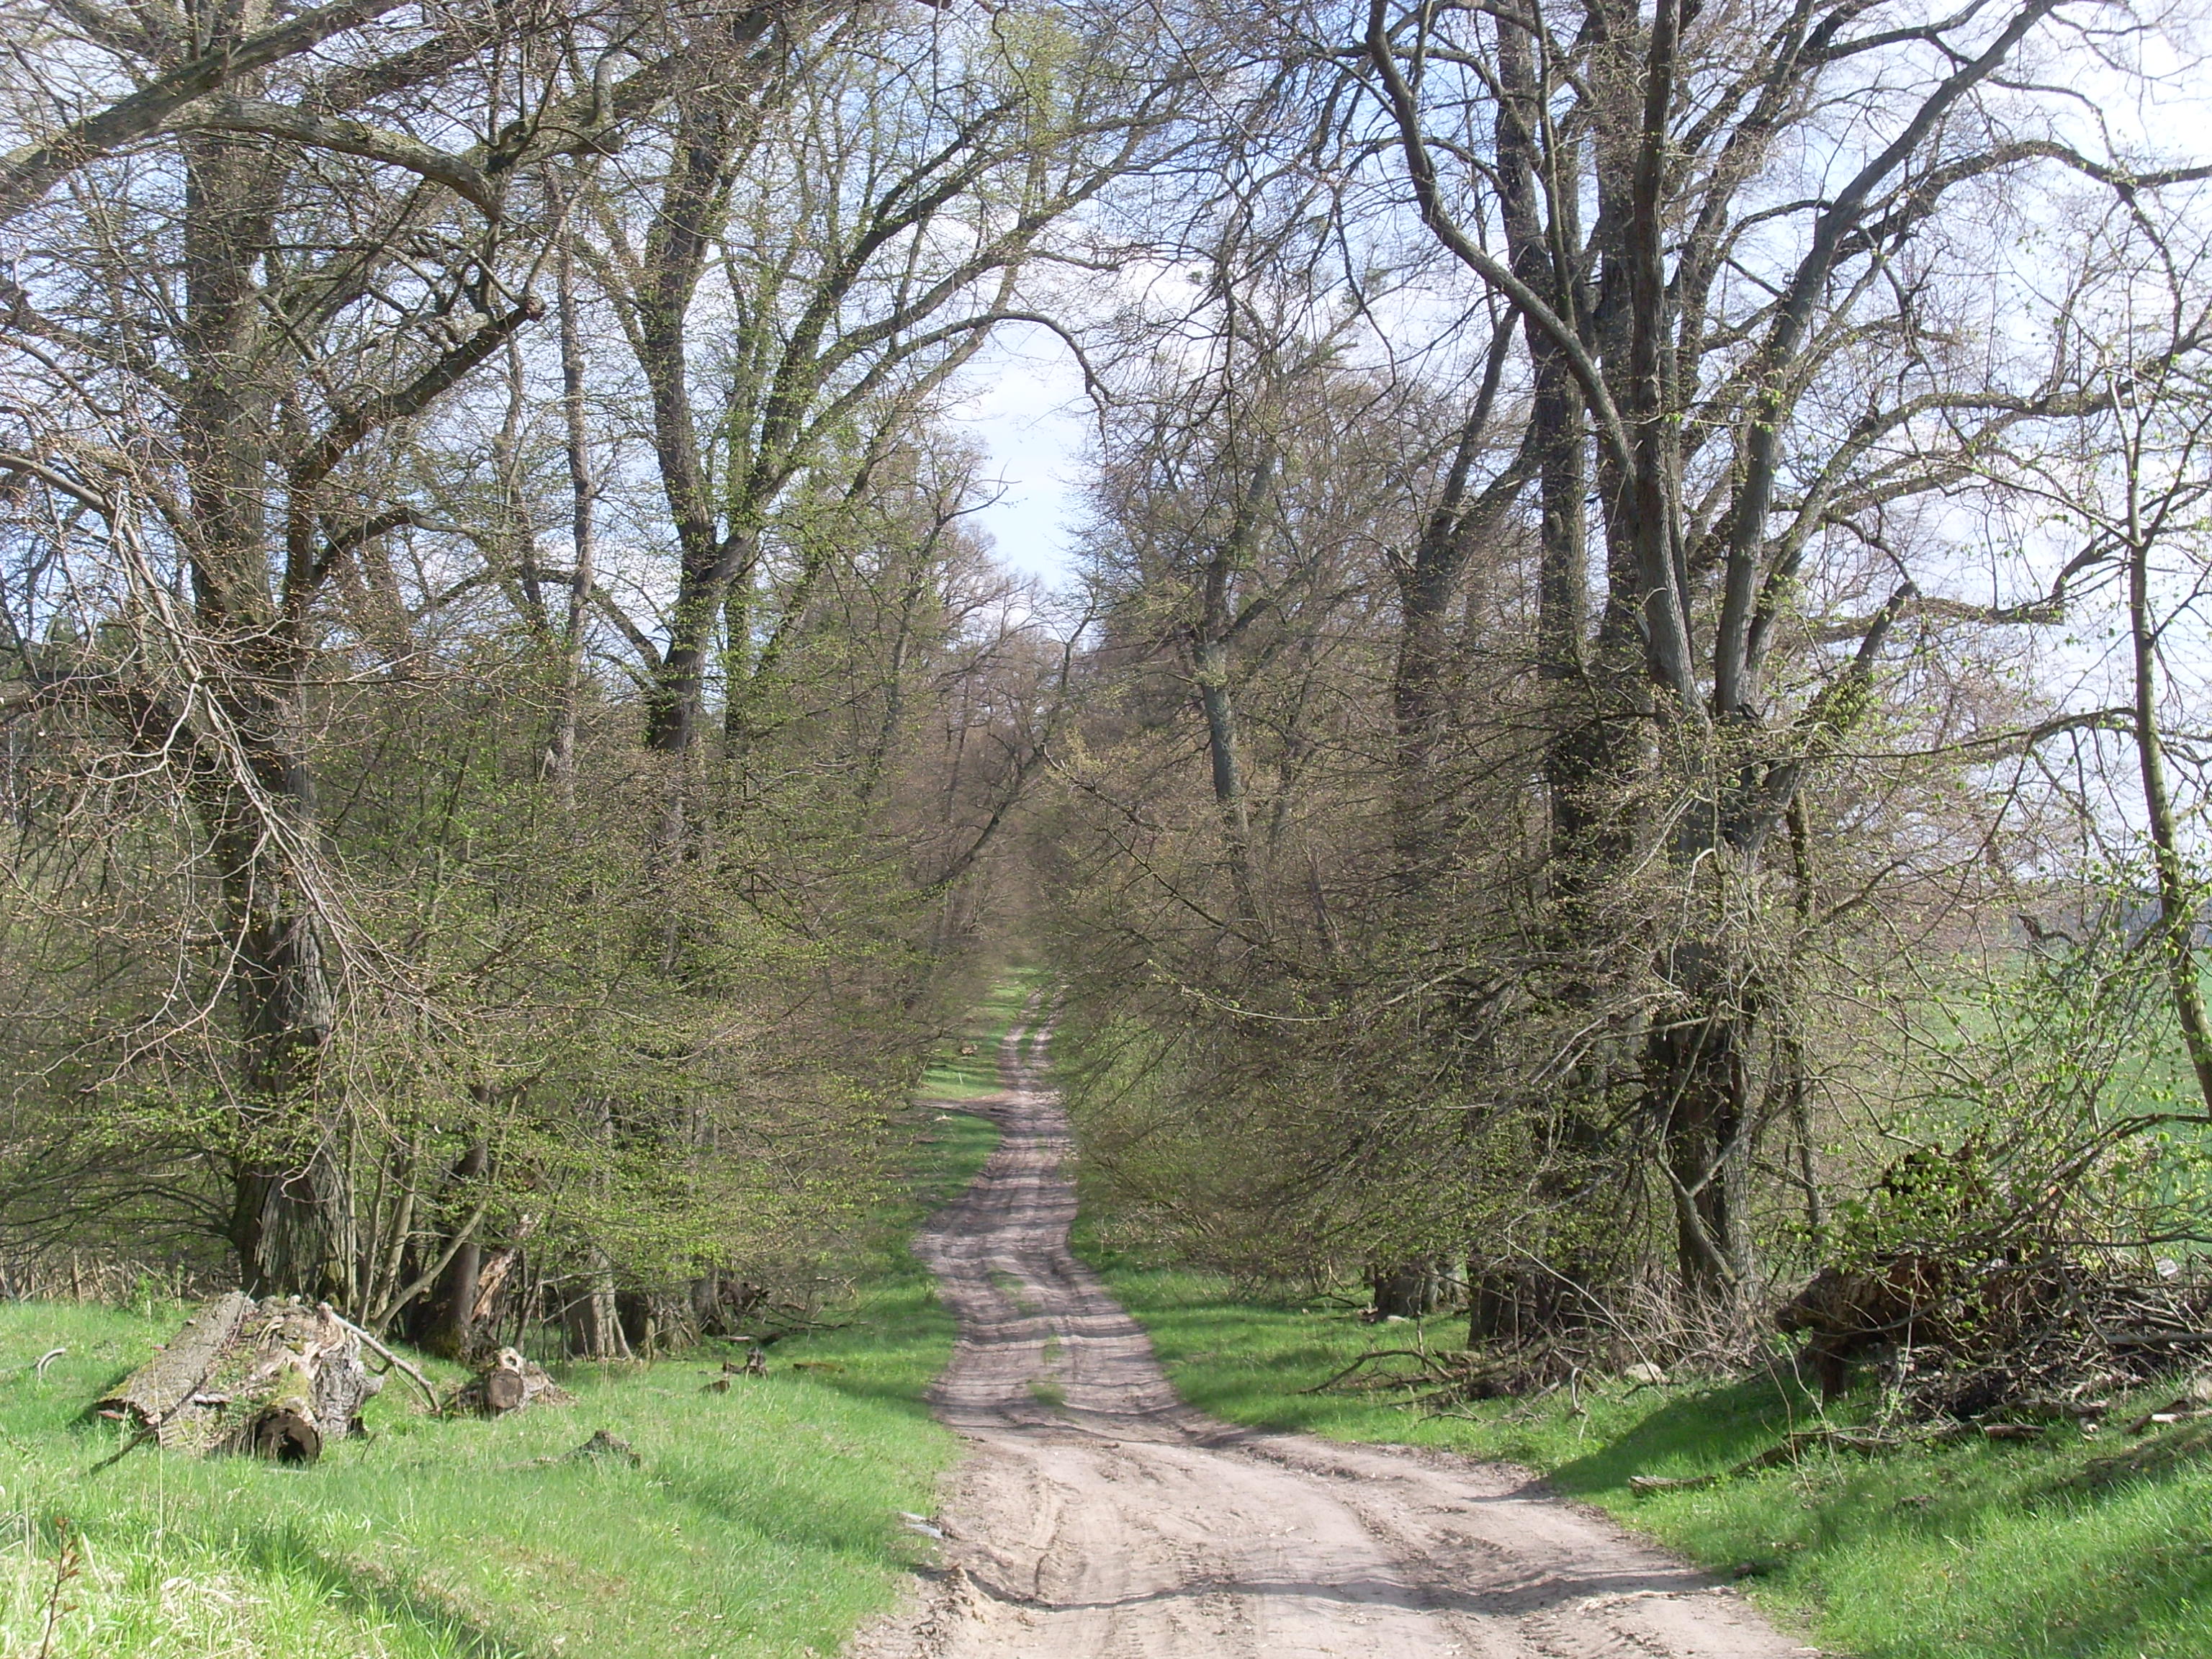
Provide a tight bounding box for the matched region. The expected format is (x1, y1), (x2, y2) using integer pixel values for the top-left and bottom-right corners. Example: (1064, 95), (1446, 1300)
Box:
(0, 1092), (995, 1659)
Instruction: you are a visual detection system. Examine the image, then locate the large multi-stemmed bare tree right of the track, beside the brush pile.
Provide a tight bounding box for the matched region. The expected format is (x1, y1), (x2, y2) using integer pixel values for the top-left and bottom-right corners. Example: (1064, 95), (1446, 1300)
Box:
(1362, 0), (2203, 1298)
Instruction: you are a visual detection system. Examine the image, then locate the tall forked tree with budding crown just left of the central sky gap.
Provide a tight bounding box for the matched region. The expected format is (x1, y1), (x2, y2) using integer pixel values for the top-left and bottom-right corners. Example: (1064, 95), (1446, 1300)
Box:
(570, 11), (1192, 755)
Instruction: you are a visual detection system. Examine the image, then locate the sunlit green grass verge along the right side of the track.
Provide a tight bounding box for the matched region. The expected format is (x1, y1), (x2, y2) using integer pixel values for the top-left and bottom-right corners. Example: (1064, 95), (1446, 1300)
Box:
(1086, 1248), (2212, 1659)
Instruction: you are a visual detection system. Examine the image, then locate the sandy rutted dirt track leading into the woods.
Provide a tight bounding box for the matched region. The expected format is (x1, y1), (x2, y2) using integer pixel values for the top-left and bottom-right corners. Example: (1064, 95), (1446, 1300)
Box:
(852, 1008), (1814, 1659)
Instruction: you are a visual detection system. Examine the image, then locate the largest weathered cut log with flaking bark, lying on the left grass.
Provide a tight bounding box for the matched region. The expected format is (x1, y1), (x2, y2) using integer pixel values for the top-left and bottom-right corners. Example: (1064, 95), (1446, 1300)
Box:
(95, 1292), (385, 1462)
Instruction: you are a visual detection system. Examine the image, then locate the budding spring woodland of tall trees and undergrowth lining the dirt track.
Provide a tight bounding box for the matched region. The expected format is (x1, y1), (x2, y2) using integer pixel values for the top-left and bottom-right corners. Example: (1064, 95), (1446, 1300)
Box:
(0, 0), (2212, 1398)
